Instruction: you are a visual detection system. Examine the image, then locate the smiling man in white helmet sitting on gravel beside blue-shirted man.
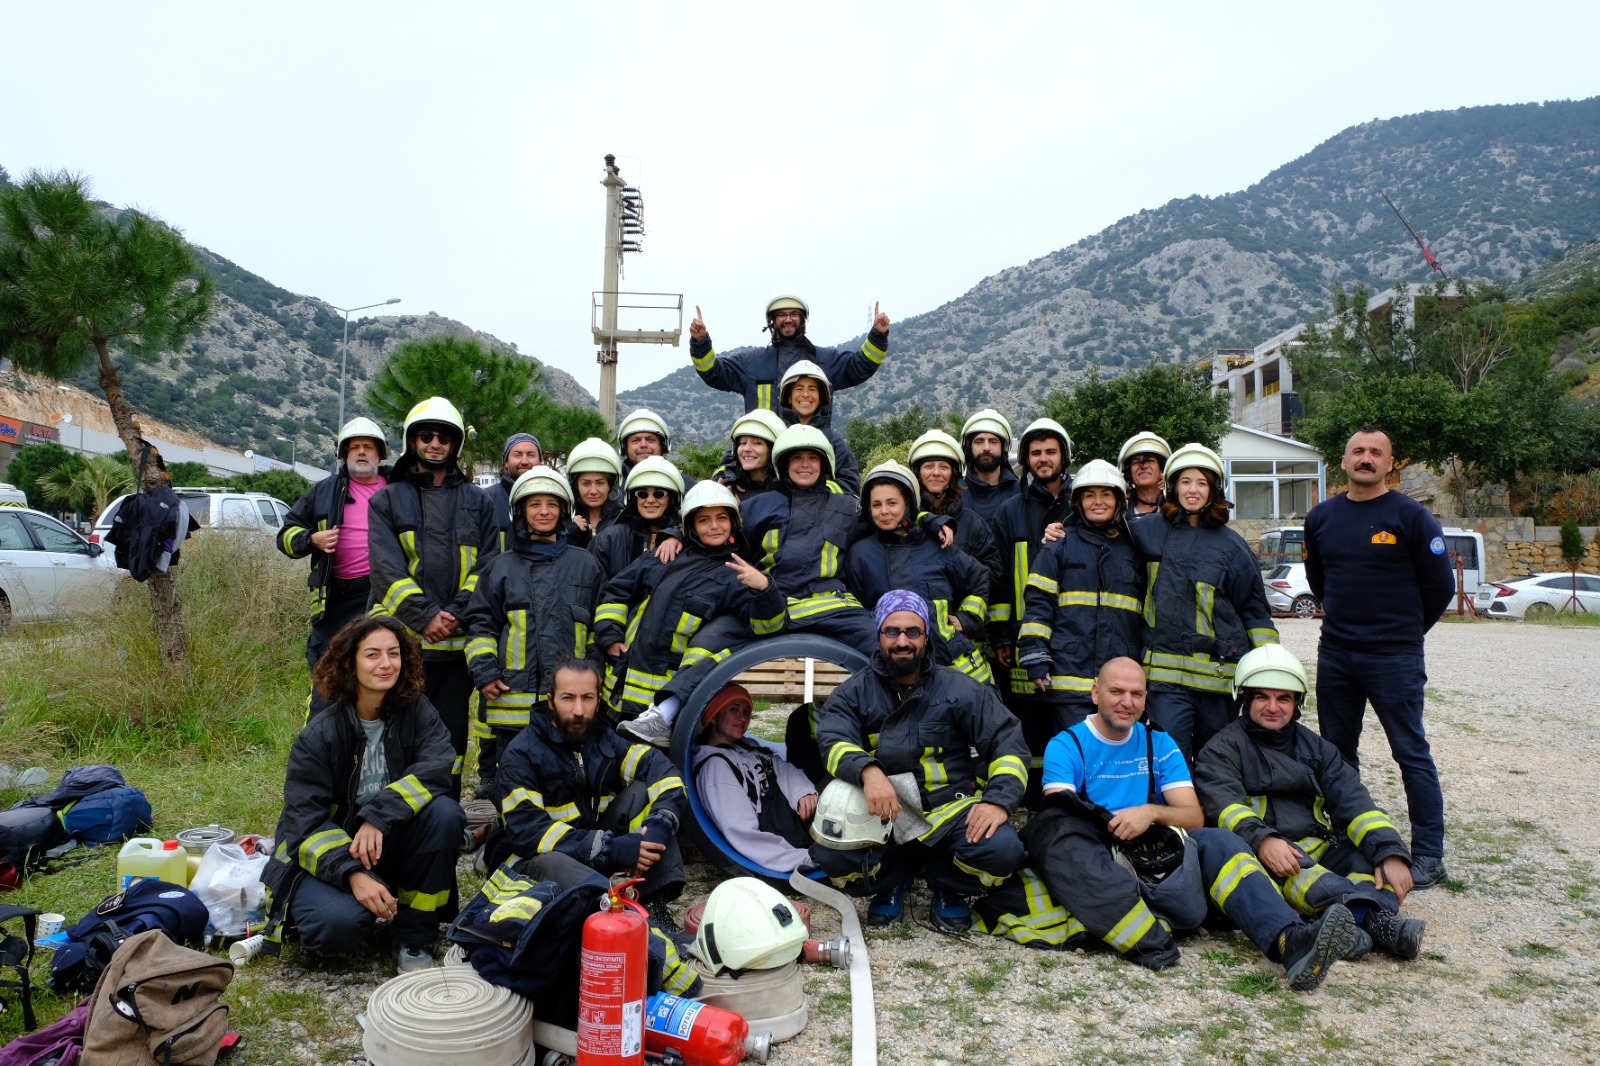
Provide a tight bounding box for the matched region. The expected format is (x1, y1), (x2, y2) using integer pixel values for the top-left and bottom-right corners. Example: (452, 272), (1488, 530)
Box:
(1195, 643), (1426, 959)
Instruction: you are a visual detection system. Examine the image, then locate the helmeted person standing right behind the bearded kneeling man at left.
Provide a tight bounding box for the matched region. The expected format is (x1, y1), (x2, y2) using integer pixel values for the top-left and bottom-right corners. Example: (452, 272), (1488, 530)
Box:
(466, 466), (603, 799)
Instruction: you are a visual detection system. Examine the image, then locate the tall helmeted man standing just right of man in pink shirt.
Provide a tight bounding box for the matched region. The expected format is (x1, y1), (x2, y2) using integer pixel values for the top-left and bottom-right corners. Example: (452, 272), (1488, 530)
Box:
(368, 395), (499, 795)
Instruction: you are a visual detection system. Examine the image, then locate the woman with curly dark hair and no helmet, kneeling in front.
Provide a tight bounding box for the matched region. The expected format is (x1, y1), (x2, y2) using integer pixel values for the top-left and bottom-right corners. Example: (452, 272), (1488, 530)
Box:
(262, 616), (467, 973)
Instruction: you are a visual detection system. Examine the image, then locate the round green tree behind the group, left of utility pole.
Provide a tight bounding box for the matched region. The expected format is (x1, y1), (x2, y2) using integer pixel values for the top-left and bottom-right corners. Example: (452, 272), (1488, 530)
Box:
(366, 335), (566, 469)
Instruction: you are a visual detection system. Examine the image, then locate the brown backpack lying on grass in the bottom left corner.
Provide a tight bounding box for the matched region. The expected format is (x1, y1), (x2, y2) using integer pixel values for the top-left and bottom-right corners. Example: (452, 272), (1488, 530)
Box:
(83, 928), (234, 1066)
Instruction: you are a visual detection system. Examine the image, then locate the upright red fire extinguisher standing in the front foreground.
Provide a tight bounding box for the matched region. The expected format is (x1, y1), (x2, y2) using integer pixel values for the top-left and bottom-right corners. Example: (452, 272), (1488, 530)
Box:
(578, 877), (650, 1066)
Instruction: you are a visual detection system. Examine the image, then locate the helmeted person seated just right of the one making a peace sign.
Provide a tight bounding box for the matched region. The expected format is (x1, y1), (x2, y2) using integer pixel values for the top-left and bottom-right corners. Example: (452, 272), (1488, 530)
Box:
(739, 426), (877, 655)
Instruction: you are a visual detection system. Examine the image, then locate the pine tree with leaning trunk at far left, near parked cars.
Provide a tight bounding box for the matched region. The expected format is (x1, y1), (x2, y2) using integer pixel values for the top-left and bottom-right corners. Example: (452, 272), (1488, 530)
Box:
(0, 173), (211, 666)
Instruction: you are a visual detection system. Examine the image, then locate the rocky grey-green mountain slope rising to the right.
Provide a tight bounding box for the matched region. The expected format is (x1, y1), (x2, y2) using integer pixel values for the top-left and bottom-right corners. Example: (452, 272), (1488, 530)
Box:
(621, 98), (1600, 439)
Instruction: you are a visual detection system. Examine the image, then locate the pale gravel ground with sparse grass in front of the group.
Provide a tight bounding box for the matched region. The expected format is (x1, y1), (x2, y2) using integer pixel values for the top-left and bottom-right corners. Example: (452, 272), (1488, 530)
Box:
(237, 619), (1600, 1066)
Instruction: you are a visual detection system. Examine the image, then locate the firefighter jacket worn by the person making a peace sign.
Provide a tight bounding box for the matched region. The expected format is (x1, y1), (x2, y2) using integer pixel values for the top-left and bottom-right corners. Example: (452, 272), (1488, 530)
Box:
(595, 533), (784, 707)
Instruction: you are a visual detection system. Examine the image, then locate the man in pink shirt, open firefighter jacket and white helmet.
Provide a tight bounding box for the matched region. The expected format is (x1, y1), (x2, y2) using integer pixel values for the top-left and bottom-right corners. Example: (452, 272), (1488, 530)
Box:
(278, 418), (389, 681)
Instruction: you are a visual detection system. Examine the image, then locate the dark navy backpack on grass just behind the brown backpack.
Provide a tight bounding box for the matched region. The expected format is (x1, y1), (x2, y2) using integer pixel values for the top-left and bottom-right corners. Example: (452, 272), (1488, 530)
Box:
(50, 879), (210, 992)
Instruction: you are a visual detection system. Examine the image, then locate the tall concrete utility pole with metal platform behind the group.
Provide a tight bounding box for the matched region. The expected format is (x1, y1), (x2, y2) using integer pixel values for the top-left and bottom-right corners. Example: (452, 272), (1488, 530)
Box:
(590, 155), (683, 431)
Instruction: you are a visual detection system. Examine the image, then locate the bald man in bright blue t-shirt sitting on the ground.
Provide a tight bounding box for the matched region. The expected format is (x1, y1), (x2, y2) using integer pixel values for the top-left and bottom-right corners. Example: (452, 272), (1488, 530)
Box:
(1022, 658), (1370, 992)
